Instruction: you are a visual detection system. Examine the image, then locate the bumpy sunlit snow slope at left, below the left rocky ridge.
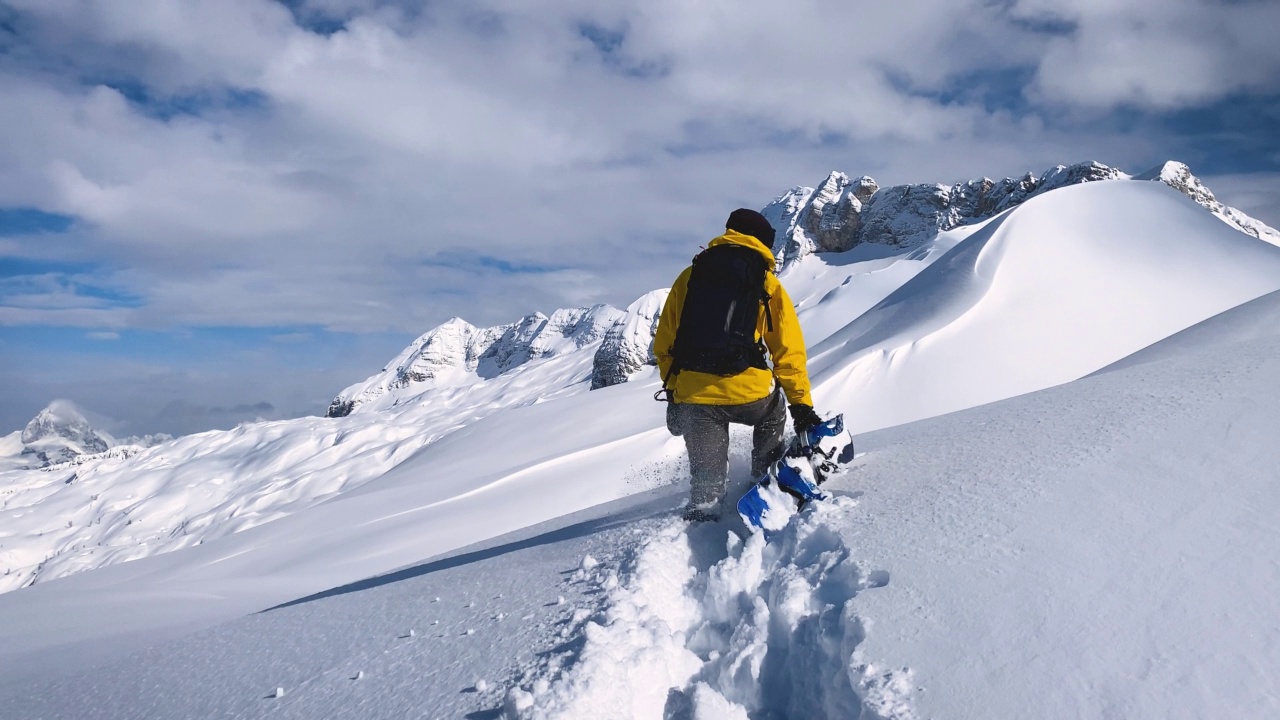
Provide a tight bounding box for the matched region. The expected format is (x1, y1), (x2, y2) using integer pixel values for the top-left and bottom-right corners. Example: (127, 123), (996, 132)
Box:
(0, 338), (619, 591)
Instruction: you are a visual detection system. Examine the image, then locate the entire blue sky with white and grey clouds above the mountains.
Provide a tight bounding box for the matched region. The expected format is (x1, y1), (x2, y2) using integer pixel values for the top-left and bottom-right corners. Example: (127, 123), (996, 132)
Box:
(0, 0), (1280, 434)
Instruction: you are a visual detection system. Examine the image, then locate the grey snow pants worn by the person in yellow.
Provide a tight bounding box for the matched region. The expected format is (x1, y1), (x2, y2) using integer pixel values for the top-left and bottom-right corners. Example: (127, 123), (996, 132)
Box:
(667, 387), (787, 505)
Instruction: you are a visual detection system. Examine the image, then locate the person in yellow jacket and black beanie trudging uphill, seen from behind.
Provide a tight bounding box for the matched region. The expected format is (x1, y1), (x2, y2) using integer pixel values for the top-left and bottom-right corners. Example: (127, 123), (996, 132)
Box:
(654, 209), (822, 521)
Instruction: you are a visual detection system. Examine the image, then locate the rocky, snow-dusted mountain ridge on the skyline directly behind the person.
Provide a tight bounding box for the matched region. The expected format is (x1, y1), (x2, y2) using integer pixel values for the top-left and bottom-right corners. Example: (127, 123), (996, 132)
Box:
(328, 160), (1280, 404)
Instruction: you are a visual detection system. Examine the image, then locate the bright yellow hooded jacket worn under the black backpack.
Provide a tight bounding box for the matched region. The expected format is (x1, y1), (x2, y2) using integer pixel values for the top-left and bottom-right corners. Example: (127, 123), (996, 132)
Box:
(653, 231), (813, 406)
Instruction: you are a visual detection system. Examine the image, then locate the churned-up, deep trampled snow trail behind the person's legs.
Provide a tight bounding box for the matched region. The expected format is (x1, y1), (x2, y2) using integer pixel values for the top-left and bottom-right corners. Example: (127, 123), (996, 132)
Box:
(507, 498), (915, 720)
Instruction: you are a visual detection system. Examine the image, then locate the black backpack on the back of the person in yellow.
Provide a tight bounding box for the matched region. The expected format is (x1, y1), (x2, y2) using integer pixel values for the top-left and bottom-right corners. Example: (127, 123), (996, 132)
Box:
(663, 245), (773, 387)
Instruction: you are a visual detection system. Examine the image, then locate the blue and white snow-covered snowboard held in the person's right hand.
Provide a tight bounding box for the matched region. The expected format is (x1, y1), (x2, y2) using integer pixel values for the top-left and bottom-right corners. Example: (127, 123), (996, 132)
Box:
(737, 415), (854, 536)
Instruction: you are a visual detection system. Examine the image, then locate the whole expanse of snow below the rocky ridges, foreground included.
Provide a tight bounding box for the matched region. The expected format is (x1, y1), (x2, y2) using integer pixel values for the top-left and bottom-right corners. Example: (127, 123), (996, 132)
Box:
(0, 175), (1280, 717)
